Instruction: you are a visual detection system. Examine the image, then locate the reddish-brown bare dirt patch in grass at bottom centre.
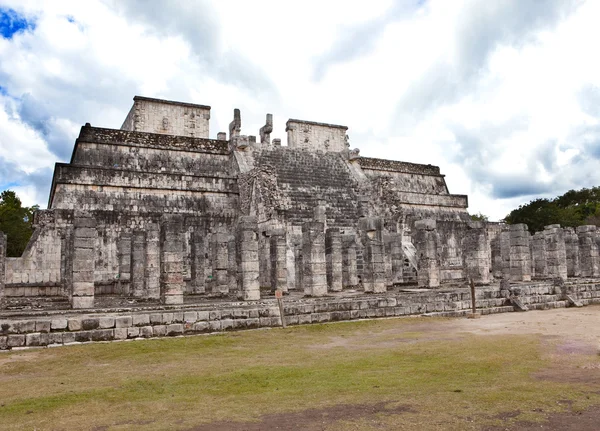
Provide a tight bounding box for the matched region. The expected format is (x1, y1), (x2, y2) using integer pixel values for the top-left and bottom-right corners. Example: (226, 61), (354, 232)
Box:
(189, 402), (413, 431)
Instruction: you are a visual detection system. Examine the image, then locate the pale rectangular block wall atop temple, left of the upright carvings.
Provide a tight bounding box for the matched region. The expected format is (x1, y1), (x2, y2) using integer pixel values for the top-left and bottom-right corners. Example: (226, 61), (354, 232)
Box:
(121, 96), (210, 138)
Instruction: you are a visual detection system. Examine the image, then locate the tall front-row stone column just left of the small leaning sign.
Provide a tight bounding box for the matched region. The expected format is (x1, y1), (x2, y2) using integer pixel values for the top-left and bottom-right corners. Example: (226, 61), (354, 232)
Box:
(236, 216), (260, 301)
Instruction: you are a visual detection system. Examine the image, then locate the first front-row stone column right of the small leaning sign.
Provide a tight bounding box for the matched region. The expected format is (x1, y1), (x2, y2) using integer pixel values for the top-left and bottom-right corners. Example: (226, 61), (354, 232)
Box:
(302, 222), (327, 296)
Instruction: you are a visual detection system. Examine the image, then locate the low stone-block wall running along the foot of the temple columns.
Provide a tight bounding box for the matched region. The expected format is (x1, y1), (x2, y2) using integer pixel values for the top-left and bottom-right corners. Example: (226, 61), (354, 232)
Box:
(0, 280), (600, 350)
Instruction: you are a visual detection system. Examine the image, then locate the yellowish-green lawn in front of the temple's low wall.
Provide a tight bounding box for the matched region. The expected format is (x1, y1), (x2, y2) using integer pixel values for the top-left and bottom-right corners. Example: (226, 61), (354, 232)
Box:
(0, 319), (600, 430)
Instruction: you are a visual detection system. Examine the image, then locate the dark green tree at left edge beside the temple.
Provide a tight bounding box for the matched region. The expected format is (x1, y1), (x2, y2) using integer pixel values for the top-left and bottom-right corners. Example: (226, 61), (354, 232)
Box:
(0, 190), (38, 257)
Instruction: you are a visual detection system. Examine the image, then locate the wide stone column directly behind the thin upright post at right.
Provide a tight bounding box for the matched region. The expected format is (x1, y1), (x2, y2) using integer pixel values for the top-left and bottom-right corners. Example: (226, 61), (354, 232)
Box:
(462, 222), (491, 284)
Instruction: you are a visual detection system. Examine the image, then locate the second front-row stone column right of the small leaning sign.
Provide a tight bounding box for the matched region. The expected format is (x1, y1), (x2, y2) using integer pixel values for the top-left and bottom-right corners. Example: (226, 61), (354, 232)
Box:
(358, 217), (386, 293)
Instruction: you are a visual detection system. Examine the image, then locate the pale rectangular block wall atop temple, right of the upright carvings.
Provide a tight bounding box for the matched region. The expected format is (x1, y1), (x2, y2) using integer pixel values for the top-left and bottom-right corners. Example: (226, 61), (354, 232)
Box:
(285, 119), (348, 152)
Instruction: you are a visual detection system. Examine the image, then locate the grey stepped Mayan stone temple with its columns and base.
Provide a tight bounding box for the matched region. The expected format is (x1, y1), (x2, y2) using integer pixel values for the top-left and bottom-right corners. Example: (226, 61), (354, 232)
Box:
(0, 97), (600, 349)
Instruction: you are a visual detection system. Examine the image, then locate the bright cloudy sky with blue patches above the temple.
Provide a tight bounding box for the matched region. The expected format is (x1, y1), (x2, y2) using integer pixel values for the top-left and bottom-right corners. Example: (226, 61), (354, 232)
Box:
(0, 0), (600, 220)
